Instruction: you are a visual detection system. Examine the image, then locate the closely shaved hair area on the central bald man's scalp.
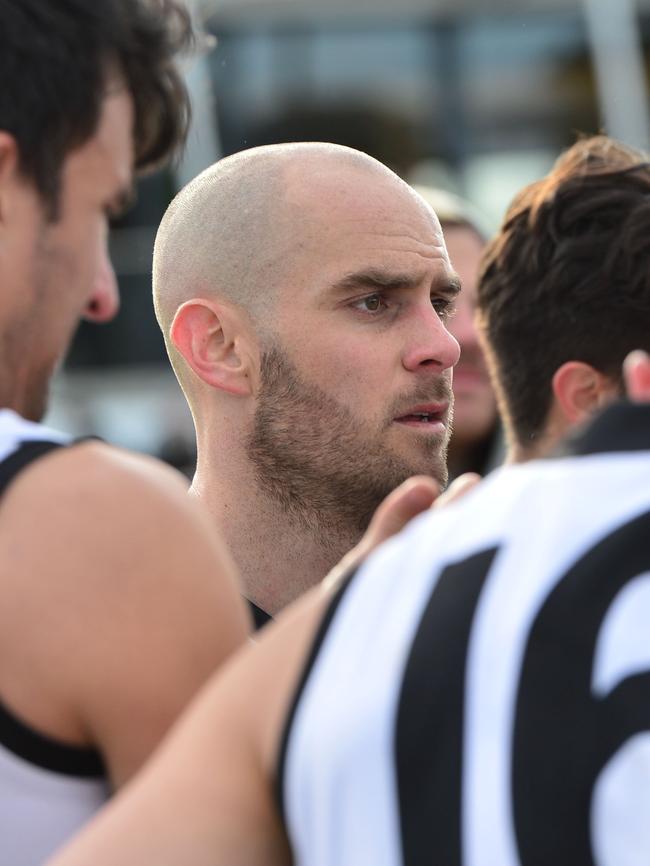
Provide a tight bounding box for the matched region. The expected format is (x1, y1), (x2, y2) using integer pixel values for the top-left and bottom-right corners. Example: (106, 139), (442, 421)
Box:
(153, 142), (426, 378)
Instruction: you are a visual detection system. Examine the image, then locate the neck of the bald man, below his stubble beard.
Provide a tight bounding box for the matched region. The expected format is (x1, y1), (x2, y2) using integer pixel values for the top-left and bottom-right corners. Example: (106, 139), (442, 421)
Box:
(191, 461), (358, 616)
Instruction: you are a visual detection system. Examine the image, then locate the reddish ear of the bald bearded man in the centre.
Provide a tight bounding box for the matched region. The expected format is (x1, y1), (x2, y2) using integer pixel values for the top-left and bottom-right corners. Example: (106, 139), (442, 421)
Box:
(170, 298), (252, 396)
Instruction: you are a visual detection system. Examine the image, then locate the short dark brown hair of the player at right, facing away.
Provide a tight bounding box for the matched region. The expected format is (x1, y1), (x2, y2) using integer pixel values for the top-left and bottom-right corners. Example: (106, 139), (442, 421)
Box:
(478, 135), (650, 449)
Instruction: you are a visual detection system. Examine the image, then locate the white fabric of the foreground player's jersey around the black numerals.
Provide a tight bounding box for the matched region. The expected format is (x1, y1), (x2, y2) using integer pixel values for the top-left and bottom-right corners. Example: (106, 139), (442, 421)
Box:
(285, 452), (650, 866)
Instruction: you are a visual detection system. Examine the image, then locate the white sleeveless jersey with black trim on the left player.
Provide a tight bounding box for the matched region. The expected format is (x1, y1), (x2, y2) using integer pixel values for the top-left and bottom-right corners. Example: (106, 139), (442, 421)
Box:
(0, 409), (109, 866)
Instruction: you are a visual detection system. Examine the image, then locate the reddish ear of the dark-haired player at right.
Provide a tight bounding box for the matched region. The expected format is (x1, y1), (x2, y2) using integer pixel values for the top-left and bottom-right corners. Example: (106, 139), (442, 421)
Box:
(553, 361), (619, 424)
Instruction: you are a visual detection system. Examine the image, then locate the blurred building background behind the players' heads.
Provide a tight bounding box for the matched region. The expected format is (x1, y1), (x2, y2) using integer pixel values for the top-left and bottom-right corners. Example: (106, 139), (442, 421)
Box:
(46, 0), (650, 473)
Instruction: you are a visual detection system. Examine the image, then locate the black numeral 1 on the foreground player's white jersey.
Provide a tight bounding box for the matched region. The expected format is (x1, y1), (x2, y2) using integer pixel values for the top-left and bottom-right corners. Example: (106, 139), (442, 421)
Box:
(394, 548), (497, 866)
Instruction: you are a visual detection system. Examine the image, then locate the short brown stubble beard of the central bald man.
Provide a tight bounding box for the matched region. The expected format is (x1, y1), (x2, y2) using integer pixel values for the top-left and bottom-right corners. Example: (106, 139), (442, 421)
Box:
(247, 347), (452, 548)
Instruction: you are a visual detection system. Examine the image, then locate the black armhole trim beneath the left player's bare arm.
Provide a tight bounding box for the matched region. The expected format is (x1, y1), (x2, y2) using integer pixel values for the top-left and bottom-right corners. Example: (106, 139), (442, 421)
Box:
(0, 703), (106, 779)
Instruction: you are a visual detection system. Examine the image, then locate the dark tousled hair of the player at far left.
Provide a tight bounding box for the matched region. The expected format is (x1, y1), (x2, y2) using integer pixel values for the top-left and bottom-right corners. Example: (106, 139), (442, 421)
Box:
(0, 0), (191, 213)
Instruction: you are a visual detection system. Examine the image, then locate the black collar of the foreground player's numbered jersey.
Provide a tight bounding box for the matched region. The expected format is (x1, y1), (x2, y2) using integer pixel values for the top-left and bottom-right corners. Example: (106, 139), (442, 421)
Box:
(554, 402), (650, 456)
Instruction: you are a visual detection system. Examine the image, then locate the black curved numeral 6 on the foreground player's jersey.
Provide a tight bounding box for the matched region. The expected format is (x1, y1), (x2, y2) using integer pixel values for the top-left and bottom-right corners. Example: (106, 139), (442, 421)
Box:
(512, 510), (650, 866)
